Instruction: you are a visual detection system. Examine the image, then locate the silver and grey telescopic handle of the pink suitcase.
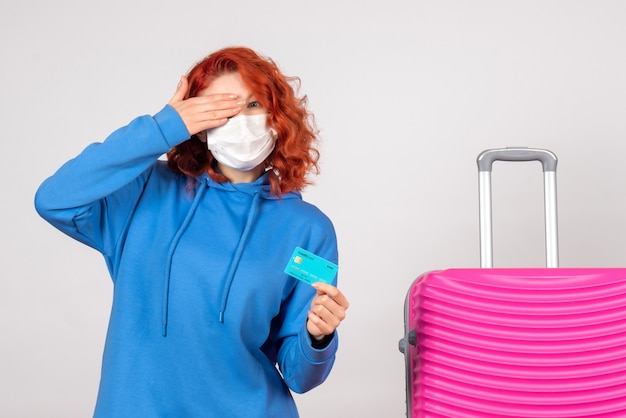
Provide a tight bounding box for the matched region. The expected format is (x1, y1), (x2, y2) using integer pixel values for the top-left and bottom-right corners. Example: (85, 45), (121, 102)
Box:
(476, 147), (559, 268)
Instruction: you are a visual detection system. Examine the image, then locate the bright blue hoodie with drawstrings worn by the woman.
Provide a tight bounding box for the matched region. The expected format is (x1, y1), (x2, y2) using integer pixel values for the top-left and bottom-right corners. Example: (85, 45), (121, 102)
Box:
(35, 105), (337, 418)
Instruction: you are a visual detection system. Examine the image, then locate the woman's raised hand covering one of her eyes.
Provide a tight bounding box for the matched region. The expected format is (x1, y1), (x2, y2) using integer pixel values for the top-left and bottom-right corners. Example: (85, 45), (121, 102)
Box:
(168, 76), (243, 135)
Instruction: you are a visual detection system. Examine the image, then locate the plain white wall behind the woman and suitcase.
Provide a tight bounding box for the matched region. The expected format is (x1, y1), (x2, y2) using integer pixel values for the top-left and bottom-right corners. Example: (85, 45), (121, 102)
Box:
(0, 0), (626, 418)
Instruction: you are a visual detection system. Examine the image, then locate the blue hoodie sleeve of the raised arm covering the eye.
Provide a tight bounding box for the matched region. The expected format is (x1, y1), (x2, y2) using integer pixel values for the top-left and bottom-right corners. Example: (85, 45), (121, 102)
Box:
(35, 105), (189, 256)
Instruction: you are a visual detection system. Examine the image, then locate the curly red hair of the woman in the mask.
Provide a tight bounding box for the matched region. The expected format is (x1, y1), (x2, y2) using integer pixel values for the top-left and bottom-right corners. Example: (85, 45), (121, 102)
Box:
(167, 47), (319, 196)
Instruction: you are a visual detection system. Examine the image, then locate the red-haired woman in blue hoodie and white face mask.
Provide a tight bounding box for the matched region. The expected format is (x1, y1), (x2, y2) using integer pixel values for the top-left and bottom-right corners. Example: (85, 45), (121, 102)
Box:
(35, 48), (348, 418)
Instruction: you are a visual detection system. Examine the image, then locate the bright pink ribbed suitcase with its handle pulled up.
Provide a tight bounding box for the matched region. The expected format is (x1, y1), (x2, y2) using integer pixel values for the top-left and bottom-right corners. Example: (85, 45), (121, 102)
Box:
(400, 148), (626, 418)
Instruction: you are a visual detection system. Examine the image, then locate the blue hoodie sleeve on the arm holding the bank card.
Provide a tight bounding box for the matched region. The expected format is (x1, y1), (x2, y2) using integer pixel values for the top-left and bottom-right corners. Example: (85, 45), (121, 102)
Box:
(278, 224), (338, 393)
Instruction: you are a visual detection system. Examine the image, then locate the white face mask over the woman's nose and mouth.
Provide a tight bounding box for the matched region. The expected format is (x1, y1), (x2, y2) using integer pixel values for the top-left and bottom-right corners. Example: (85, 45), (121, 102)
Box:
(206, 114), (276, 171)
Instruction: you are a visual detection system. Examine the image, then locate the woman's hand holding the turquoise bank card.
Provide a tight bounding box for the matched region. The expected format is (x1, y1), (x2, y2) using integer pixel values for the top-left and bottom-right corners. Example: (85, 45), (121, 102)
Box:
(306, 282), (350, 341)
